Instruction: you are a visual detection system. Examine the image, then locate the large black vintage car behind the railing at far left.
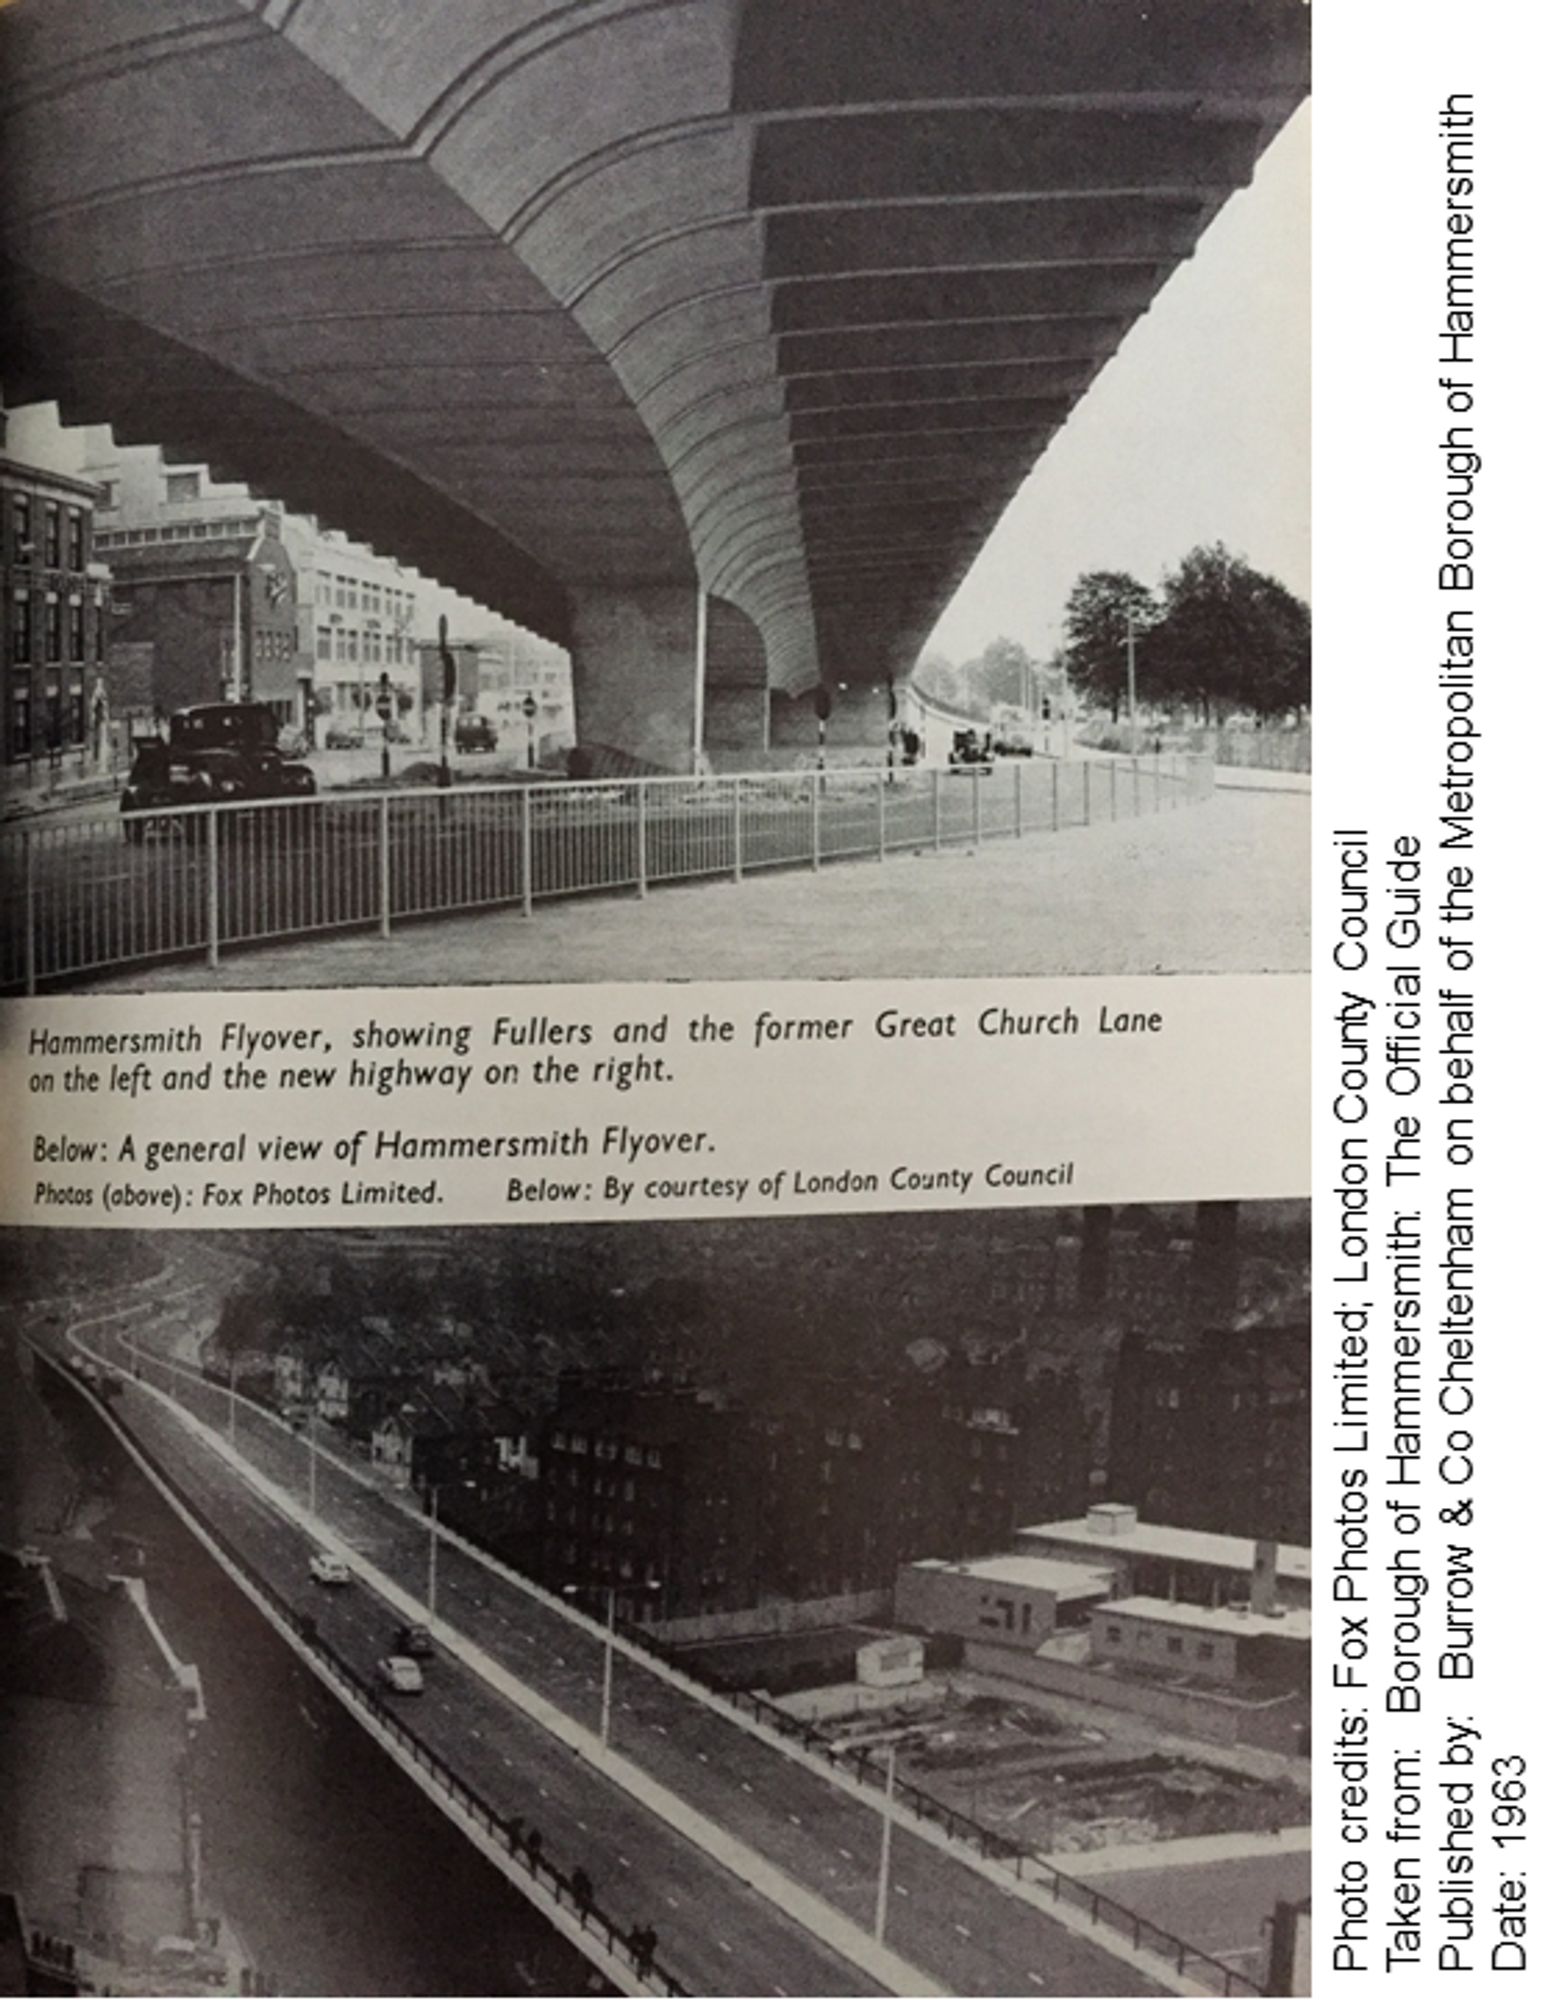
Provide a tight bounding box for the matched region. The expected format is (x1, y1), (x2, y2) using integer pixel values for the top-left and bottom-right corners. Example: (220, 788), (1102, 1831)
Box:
(120, 702), (314, 842)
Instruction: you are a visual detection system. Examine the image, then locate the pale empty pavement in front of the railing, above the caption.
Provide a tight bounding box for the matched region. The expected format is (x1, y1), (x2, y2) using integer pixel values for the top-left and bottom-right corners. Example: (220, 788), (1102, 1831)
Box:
(94, 774), (1311, 992)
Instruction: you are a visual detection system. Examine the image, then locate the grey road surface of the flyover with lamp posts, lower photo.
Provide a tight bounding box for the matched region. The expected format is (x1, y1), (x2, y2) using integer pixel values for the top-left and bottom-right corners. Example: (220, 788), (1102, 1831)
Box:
(33, 1288), (1207, 1994)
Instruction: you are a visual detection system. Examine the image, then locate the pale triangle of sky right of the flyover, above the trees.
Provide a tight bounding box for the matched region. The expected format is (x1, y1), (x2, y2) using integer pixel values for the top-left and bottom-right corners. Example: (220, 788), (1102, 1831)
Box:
(927, 104), (1311, 660)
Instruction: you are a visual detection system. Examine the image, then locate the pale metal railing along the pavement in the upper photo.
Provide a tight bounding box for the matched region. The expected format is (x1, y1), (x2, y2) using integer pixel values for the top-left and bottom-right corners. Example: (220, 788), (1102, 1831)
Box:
(0, 754), (1213, 992)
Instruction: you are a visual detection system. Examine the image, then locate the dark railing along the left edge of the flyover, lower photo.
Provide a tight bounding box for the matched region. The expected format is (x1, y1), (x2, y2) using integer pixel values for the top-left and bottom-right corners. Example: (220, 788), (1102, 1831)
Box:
(34, 1348), (688, 1996)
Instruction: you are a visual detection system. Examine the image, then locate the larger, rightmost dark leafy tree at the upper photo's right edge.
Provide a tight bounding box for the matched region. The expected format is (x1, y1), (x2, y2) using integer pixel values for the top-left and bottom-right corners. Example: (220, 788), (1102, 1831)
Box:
(1149, 542), (1311, 722)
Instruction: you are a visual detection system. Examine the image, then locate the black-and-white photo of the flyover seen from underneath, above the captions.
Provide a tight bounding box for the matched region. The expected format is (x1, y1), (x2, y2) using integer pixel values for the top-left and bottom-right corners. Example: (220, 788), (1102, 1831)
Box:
(0, 0), (1311, 992)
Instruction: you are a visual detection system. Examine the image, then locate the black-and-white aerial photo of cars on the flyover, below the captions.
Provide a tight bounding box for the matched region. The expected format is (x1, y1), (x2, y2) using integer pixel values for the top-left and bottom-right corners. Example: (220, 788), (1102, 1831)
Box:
(0, 1202), (1311, 1996)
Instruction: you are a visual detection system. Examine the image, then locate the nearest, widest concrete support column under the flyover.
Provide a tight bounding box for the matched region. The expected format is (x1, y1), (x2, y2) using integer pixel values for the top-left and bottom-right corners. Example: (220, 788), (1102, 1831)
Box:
(570, 584), (704, 774)
